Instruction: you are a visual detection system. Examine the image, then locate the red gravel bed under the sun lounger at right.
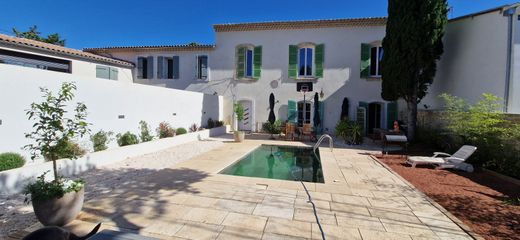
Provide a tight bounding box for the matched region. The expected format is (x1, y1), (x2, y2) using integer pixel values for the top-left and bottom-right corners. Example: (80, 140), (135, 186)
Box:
(376, 155), (520, 239)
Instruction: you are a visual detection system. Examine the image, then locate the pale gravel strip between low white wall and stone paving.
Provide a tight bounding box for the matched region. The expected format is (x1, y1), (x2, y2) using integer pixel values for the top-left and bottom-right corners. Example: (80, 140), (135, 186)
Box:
(0, 139), (223, 239)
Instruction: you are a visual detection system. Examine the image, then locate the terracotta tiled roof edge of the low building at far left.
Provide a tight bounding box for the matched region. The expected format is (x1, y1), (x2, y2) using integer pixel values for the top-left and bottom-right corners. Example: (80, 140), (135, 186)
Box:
(0, 34), (134, 67)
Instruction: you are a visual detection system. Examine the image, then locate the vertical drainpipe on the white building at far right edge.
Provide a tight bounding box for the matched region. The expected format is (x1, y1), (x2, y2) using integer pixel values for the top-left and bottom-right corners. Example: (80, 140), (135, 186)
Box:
(503, 6), (516, 113)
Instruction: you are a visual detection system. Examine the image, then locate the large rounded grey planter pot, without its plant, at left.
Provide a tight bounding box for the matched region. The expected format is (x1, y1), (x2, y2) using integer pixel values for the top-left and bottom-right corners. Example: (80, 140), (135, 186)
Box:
(33, 187), (85, 227)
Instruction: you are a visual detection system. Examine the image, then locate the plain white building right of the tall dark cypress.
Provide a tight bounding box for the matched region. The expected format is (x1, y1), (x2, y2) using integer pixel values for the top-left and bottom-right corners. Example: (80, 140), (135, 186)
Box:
(419, 3), (520, 114)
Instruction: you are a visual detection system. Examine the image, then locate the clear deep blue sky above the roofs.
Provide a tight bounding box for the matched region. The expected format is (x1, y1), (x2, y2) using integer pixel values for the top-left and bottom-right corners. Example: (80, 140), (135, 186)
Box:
(0, 0), (518, 49)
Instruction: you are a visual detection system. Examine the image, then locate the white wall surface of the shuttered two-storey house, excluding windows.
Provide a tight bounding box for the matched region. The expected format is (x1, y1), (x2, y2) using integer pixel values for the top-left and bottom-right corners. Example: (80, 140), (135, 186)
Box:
(97, 25), (396, 133)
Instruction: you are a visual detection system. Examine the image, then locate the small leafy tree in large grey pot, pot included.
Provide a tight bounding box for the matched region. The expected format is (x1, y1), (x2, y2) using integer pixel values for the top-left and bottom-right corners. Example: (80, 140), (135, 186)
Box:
(24, 82), (90, 226)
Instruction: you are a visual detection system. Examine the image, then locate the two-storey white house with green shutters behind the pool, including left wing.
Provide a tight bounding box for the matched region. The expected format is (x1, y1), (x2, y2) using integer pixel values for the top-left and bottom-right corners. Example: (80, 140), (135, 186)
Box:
(84, 18), (397, 132)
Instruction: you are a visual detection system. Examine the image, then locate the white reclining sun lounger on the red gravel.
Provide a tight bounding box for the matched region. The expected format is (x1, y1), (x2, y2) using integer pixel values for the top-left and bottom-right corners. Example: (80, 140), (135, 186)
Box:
(406, 145), (477, 172)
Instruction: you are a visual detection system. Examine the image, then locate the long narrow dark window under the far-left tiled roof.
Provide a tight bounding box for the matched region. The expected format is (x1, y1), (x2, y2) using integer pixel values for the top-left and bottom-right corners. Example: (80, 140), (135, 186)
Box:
(0, 49), (71, 73)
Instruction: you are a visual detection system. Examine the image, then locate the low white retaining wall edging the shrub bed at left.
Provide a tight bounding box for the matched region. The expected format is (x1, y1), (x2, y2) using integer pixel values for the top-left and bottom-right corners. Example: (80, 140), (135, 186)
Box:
(0, 126), (228, 194)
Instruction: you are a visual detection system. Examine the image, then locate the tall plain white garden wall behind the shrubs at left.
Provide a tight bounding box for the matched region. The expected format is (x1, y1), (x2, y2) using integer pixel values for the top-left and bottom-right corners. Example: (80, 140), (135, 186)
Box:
(0, 64), (226, 161)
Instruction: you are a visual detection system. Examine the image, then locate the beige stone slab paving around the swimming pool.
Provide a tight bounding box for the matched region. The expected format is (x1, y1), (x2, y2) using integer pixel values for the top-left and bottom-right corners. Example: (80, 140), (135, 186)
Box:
(17, 136), (472, 240)
